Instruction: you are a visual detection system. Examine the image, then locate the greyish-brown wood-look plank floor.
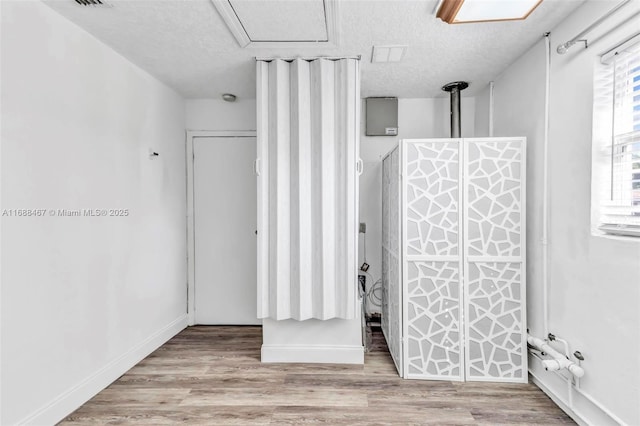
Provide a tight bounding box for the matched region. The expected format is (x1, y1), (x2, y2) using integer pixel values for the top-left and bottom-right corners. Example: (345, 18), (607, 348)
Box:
(60, 327), (573, 425)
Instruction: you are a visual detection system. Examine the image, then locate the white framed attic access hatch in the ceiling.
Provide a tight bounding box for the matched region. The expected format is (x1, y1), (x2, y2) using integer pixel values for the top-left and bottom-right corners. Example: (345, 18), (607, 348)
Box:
(212, 0), (336, 47)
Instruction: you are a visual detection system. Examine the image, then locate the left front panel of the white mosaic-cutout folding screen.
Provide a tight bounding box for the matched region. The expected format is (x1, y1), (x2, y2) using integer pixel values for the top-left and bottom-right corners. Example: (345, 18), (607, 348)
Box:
(402, 139), (464, 381)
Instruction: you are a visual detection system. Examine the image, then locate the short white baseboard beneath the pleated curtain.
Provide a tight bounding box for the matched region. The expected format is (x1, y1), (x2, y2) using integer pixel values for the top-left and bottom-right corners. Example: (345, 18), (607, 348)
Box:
(262, 345), (364, 364)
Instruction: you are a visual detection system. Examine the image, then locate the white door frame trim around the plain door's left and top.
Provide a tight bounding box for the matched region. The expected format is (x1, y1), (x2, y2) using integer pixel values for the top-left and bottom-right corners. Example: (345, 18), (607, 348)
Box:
(185, 130), (257, 325)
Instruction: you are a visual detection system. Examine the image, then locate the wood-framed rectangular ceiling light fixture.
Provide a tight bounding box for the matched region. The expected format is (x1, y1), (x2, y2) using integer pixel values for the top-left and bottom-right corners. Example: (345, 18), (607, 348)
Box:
(436, 0), (542, 24)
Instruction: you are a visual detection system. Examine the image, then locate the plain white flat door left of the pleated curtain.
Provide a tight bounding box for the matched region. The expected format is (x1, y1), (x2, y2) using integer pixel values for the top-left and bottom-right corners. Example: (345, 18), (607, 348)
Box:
(193, 137), (261, 325)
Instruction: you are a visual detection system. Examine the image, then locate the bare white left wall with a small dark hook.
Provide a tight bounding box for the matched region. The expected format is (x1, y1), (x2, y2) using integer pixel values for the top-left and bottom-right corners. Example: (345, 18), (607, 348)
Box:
(0, 1), (186, 425)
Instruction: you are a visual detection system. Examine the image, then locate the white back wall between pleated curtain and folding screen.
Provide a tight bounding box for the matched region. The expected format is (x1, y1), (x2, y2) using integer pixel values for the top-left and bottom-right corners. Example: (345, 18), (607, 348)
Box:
(359, 95), (475, 306)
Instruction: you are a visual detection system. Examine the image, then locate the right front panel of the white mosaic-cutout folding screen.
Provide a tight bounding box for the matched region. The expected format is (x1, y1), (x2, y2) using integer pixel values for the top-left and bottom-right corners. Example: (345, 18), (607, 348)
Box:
(463, 138), (528, 383)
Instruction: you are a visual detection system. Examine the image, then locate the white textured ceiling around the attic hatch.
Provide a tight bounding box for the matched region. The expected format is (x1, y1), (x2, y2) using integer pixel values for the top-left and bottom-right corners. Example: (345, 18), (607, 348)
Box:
(46, 0), (588, 98)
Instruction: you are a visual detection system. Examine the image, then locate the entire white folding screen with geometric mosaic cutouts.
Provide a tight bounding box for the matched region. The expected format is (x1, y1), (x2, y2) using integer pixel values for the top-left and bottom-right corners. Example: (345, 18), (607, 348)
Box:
(382, 138), (527, 382)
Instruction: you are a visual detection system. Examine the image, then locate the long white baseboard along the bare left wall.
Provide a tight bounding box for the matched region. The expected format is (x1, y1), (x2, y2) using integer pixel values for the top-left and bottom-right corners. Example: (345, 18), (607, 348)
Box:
(17, 314), (187, 425)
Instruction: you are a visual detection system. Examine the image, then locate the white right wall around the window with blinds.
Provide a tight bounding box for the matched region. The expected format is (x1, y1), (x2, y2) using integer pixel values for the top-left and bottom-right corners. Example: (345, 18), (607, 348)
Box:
(477, 1), (640, 425)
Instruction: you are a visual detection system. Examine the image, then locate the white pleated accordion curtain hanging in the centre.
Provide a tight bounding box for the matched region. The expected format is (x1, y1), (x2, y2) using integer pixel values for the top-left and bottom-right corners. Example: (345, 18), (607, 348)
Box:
(256, 58), (362, 320)
